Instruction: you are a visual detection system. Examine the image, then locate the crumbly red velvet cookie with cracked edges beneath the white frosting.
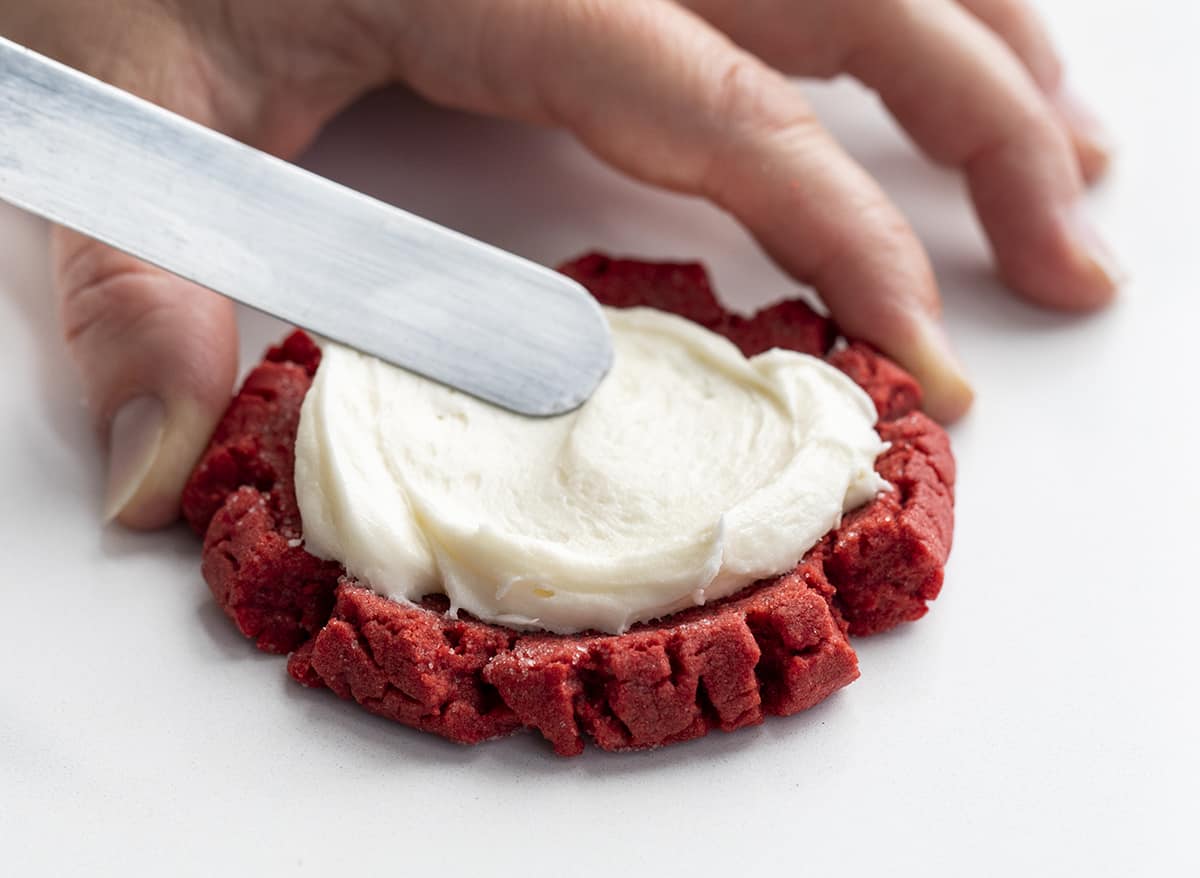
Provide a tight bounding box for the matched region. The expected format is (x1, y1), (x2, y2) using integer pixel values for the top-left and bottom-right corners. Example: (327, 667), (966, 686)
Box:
(184, 254), (954, 754)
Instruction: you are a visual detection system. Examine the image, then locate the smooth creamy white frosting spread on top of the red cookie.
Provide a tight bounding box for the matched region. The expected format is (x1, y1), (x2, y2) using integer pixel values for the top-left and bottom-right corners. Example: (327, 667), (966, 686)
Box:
(295, 308), (886, 633)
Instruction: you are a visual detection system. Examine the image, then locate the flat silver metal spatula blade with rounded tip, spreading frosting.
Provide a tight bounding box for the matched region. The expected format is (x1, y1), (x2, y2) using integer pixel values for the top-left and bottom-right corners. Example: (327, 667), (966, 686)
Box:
(0, 38), (612, 415)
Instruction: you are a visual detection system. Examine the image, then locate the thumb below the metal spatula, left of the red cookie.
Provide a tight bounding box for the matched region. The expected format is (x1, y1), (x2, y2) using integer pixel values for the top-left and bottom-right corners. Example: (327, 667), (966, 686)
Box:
(52, 229), (238, 528)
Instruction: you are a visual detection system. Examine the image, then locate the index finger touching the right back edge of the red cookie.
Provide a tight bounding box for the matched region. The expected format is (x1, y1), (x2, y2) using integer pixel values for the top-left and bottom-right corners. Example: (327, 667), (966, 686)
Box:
(393, 2), (972, 420)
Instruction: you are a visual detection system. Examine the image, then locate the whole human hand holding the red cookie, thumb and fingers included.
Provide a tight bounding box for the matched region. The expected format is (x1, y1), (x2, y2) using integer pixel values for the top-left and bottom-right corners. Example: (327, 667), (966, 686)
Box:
(0, 0), (1116, 527)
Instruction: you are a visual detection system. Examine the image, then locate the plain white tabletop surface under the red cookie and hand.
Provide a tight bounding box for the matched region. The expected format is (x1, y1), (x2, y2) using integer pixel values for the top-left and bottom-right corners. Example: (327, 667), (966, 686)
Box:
(0, 0), (1200, 876)
